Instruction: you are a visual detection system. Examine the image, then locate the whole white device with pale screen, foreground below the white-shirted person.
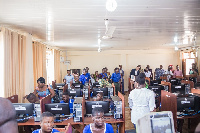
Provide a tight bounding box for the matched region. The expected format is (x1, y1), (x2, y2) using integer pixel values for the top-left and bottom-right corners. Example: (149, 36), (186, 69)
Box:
(136, 111), (175, 133)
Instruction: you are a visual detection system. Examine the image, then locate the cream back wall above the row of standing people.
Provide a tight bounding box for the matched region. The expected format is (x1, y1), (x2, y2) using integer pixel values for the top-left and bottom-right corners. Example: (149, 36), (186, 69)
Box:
(61, 50), (180, 89)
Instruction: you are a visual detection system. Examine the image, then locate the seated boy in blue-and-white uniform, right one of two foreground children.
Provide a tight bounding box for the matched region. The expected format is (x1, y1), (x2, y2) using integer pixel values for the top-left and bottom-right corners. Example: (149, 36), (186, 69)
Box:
(83, 107), (114, 133)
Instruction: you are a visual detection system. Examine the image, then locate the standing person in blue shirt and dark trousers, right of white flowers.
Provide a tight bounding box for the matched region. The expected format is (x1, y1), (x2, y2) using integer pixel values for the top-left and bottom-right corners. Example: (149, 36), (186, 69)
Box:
(111, 68), (121, 95)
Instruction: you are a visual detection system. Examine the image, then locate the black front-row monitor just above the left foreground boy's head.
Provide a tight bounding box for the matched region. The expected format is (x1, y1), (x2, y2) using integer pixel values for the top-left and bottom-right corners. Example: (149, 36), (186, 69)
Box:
(45, 103), (70, 115)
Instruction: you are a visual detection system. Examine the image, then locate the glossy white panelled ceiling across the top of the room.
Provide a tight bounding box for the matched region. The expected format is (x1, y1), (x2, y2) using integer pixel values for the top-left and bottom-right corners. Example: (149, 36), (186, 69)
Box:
(0, 0), (200, 50)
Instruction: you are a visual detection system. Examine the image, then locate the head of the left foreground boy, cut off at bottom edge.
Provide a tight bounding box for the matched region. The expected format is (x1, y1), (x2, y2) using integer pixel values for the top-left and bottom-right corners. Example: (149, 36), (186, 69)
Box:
(40, 112), (54, 133)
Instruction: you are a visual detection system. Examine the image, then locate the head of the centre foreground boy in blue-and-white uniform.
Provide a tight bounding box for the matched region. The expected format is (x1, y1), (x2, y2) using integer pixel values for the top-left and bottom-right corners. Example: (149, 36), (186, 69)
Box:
(92, 107), (104, 128)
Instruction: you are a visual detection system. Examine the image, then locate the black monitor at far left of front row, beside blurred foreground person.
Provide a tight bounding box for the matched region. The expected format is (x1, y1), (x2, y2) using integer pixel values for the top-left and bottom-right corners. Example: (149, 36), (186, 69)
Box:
(13, 103), (34, 116)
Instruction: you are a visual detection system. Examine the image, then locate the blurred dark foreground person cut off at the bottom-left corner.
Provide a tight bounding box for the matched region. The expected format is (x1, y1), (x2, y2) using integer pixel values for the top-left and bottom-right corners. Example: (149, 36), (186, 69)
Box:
(0, 97), (18, 133)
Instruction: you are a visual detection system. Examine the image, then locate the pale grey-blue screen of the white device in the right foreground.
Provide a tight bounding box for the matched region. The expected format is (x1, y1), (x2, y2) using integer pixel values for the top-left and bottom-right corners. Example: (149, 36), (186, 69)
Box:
(150, 114), (173, 133)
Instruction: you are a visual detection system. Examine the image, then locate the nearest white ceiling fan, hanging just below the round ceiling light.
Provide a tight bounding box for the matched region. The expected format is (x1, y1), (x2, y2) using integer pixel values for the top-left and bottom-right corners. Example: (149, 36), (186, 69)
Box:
(102, 19), (116, 39)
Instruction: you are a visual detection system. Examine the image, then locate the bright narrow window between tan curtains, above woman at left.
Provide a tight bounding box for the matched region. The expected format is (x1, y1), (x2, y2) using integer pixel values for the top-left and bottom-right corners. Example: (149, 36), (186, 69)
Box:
(46, 49), (54, 84)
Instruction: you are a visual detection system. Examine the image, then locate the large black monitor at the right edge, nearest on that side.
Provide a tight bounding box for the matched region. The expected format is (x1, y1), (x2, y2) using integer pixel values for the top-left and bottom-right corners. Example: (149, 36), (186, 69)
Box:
(177, 95), (199, 112)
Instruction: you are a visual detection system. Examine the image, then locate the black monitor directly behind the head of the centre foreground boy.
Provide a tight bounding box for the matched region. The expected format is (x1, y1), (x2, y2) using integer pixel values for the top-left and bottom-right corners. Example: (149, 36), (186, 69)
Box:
(85, 101), (110, 114)
